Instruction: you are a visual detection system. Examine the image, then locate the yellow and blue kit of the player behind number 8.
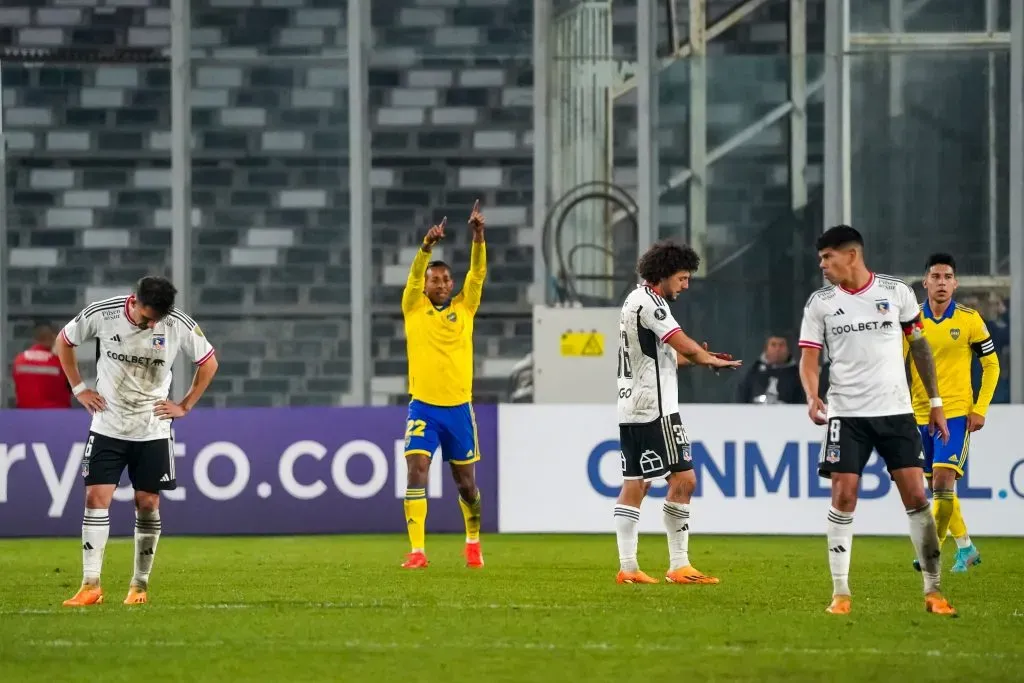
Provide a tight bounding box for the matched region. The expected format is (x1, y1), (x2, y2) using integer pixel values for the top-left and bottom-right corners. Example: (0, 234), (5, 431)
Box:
(904, 301), (999, 571)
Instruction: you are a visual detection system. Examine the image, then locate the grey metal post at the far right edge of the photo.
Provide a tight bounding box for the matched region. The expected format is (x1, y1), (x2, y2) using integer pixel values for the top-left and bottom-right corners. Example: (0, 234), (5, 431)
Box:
(1010, 2), (1024, 403)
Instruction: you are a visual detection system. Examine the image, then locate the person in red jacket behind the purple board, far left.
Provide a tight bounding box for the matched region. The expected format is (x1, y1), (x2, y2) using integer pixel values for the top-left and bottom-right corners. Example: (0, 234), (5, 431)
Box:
(12, 324), (72, 410)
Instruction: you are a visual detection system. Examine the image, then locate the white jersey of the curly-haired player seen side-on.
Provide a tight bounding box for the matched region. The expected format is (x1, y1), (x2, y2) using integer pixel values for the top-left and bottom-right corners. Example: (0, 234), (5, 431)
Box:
(618, 285), (680, 425)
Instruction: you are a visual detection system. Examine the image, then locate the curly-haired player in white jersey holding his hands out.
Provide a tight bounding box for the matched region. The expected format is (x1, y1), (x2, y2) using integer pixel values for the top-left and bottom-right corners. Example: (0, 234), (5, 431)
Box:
(614, 241), (742, 584)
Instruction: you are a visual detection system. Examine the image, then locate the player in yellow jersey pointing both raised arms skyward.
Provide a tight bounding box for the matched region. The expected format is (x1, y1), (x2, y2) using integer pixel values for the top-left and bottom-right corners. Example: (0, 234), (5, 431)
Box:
(401, 201), (487, 569)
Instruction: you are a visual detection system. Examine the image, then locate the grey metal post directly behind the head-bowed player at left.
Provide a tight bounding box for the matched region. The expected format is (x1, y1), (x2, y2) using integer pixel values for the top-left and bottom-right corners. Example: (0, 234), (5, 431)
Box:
(171, 0), (194, 400)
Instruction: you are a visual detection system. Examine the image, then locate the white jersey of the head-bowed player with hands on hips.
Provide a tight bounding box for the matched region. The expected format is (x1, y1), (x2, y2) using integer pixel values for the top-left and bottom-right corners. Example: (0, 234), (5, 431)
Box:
(60, 296), (213, 441)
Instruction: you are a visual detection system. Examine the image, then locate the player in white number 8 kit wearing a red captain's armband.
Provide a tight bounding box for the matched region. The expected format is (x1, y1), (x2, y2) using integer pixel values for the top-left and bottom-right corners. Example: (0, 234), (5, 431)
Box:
(800, 225), (956, 615)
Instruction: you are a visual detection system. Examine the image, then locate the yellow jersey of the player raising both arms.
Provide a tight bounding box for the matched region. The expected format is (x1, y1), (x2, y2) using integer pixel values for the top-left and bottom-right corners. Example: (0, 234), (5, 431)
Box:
(401, 242), (487, 407)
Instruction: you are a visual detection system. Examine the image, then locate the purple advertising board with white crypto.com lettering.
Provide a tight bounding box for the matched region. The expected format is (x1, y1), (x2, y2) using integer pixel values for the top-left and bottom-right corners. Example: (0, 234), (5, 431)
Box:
(0, 405), (498, 537)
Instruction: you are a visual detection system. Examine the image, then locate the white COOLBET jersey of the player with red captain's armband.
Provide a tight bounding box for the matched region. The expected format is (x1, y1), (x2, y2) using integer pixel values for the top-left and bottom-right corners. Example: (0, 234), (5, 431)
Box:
(800, 273), (921, 418)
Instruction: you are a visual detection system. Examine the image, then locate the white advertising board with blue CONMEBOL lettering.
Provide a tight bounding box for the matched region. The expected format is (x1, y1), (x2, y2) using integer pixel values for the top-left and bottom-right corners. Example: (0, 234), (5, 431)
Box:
(499, 404), (1024, 536)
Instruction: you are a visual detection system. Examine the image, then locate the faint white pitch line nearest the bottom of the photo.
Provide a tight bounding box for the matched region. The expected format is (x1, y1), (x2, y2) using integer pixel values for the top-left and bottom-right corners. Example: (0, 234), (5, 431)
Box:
(22, 638), (1024, 659)
